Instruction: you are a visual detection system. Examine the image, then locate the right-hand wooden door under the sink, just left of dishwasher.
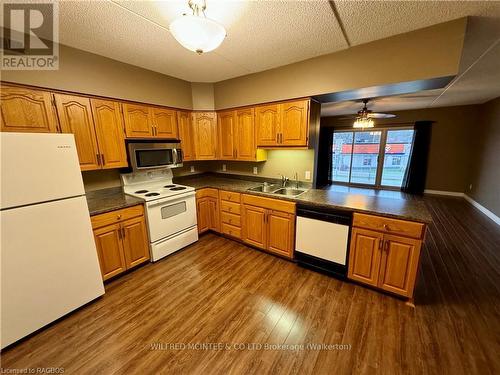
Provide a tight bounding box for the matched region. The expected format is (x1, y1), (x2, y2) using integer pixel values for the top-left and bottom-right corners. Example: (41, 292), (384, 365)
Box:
(267, 211), (295, 258)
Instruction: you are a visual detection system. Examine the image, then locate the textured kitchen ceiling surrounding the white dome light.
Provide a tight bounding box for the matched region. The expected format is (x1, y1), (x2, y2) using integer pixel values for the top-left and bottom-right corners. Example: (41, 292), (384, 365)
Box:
(54, 0), (500, 82)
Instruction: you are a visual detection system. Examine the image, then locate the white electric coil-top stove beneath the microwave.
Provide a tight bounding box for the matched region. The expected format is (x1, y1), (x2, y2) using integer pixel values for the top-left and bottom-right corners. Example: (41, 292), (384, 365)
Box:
(121, 169), (198, 262)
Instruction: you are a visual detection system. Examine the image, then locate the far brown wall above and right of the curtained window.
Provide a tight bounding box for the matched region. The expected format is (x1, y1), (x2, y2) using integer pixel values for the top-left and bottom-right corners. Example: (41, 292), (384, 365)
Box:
(321, 105), (480, 192)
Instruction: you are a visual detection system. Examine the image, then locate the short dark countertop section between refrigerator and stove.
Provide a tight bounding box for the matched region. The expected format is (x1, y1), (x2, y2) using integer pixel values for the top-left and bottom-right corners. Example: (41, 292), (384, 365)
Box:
(86, 187), (144, 216)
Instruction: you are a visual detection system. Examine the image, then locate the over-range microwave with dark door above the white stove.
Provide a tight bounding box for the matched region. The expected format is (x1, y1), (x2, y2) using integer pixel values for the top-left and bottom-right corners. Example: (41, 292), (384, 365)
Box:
(127, 141), (182, 172)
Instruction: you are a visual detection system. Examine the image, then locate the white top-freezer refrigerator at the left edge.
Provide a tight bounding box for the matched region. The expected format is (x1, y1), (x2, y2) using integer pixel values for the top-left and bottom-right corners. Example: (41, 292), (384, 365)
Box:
(0, 133), (104, 348)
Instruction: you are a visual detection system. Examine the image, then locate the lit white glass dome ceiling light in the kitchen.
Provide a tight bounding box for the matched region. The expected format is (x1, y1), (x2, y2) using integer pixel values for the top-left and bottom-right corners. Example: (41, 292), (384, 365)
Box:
(170, 0), (226, 55)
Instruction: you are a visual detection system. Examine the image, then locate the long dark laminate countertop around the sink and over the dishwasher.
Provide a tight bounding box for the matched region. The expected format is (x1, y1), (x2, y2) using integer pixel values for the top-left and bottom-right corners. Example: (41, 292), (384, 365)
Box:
(174, 175), (432, 223)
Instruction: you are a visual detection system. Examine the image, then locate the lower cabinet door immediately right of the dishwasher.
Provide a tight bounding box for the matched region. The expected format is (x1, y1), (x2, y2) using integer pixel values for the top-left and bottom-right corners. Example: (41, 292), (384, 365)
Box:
(348, 228), (383, 286)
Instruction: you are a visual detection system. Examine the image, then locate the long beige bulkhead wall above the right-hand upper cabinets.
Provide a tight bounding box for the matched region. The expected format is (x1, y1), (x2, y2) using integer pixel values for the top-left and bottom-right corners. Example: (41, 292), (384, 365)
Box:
(214, 18), (466, 109)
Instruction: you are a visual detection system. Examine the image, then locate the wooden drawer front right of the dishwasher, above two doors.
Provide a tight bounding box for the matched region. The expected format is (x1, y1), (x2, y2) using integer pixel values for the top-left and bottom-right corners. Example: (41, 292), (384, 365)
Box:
(353, 213), (425, 238)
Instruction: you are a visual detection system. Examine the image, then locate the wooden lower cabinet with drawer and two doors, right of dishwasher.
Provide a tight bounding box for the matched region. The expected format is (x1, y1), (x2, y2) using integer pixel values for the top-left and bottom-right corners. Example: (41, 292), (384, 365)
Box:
(348, 214), (425, 298)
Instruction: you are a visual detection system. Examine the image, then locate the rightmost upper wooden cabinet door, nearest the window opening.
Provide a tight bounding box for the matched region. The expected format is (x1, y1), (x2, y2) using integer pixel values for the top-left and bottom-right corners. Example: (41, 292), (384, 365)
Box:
(279, 100), (309, 146)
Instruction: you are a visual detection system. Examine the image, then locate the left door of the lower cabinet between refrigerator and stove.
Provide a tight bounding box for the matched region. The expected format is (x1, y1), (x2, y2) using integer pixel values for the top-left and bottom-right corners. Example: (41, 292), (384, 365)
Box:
(94, 224), (127, 280)
